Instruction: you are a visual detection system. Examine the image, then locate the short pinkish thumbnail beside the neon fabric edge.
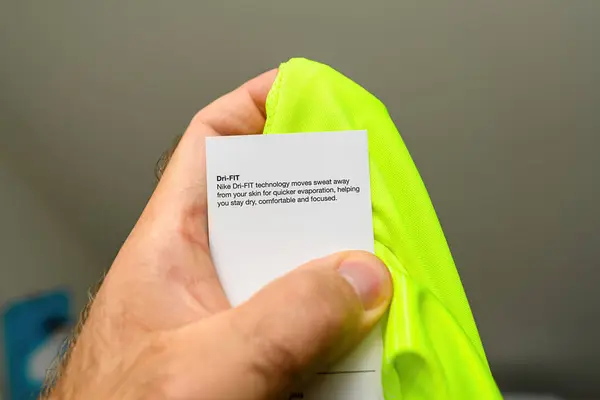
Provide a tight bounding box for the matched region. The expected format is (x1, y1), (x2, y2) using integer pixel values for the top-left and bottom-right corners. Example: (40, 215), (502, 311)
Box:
(338, 257), (390, 310)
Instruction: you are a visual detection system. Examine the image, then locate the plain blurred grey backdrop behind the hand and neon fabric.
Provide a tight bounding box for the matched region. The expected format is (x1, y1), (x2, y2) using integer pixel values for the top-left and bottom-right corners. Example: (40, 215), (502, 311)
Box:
(0, 0), (600, 398)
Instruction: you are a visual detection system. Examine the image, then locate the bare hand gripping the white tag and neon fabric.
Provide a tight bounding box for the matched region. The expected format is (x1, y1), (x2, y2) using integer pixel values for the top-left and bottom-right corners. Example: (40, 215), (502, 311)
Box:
(43, 70), (392, 400)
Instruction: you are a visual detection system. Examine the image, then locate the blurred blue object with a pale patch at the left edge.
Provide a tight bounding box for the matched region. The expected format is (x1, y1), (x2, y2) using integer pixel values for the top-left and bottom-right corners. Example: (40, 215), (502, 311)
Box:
(3, 290), (71, 400)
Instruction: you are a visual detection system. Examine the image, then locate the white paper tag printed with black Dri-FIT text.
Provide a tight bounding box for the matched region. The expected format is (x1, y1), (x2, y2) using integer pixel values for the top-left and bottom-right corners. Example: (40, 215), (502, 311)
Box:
(206, 131), (383, 400)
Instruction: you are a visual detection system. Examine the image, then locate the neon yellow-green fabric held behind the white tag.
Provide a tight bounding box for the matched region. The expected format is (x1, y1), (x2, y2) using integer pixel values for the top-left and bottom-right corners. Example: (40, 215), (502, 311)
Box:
(264, 59), (501, 400)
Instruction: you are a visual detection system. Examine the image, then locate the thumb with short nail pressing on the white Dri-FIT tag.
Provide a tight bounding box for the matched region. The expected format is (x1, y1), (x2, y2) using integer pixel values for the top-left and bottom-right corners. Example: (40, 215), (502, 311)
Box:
(224, 251), (392, 399)
